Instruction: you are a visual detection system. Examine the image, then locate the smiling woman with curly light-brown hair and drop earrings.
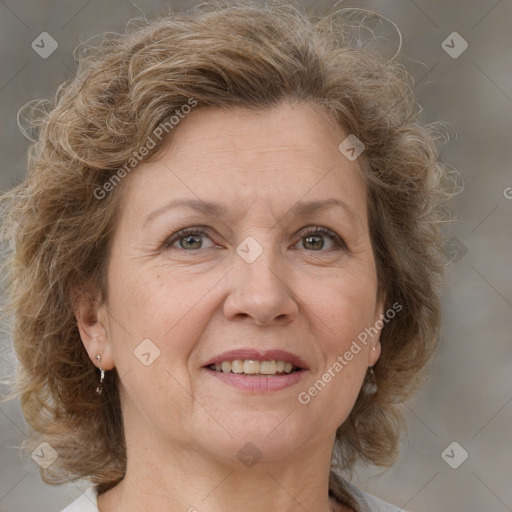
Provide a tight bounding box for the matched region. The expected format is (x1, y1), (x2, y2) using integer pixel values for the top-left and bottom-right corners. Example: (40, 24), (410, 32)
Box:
(3, 3), (449, 512)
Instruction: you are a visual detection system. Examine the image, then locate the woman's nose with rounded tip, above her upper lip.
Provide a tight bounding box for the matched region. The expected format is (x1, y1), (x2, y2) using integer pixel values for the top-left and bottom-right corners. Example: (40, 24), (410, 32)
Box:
(224, 246), (298, 326)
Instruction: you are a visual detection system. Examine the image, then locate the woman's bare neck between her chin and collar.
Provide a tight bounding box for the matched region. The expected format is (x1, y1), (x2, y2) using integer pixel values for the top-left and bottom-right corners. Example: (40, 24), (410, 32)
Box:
(98, 432), (347, 512)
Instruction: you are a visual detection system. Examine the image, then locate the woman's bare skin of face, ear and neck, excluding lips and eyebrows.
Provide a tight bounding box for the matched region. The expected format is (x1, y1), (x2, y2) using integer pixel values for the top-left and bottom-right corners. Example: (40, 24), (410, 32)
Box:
(77, 103), (383, 512)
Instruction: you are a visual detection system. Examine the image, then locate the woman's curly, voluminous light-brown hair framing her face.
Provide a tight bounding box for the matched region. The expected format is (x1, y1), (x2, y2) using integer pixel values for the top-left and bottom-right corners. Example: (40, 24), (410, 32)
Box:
(1, 2), (451, 492)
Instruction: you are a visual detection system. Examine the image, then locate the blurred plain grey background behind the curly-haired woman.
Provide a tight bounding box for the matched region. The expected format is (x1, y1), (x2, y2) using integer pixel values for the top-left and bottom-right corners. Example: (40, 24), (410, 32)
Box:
(0, 0), (512, 512)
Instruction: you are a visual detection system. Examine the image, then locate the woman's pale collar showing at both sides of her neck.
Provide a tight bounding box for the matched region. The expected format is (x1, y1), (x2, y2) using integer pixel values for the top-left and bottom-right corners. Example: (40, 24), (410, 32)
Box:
(61, 474), (406, 512)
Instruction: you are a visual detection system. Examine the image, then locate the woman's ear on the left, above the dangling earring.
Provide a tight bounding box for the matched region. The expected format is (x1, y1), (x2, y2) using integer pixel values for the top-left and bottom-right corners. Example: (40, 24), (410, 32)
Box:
(73, 288), (115, 370)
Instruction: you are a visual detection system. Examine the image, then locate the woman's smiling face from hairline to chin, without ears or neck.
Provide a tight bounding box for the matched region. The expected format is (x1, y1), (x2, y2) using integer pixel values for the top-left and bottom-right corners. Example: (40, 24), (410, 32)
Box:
(93, 104), (382, 462)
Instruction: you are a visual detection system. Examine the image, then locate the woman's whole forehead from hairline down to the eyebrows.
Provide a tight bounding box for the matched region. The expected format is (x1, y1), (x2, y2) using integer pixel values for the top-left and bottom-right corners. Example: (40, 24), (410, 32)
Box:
(118, 103), (366, 230)
